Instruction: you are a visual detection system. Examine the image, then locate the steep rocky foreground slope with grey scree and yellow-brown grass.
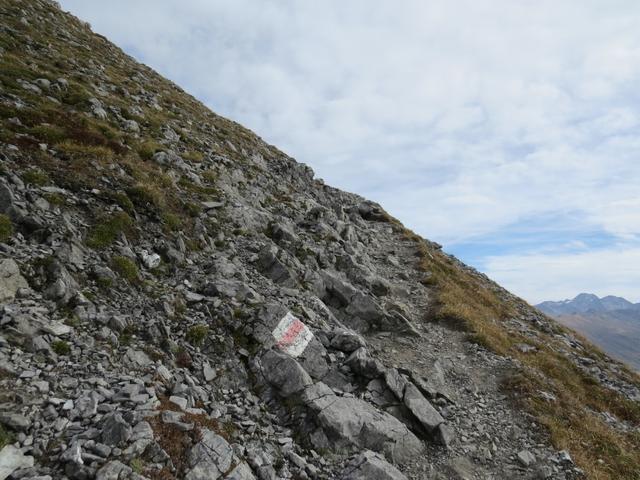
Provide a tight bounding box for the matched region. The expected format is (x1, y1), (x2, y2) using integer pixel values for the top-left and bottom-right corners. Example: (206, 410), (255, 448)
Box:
(0, 0), (640, 480)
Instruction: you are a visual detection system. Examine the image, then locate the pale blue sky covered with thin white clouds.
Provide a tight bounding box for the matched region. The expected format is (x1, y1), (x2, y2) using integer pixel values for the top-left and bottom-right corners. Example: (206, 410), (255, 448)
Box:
(60, 0), (640, 303)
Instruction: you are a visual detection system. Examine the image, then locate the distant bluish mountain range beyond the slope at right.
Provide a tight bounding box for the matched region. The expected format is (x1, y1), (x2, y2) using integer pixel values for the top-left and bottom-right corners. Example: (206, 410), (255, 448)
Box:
(536, 293), (640, 371)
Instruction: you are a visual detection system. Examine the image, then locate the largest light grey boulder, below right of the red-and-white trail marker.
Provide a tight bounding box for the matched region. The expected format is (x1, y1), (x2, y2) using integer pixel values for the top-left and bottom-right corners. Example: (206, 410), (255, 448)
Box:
(302, 382), (423, 463)
